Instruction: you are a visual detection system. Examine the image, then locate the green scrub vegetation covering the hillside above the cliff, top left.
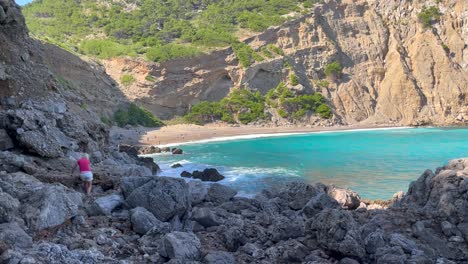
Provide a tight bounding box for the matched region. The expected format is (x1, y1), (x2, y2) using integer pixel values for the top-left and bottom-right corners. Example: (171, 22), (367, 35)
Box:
(23, 0), (315, 67)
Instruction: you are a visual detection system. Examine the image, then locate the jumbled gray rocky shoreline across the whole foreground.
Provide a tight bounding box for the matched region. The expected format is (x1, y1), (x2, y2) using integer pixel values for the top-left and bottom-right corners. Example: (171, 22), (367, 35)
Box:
(0, 138), (468, 263)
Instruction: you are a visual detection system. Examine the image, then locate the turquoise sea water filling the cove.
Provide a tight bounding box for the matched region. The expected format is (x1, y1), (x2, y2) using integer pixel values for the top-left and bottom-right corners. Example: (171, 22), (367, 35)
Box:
(153, 128), (468, 199)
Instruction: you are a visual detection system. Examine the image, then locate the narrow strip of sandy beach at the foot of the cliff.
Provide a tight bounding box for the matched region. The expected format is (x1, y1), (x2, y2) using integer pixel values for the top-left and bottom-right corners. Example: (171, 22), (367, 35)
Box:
(111, 124), (402, 146)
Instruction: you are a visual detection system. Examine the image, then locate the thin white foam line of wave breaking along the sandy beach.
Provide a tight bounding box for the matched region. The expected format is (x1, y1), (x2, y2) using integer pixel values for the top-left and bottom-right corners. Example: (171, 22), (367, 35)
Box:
(157, 126), (414, 147)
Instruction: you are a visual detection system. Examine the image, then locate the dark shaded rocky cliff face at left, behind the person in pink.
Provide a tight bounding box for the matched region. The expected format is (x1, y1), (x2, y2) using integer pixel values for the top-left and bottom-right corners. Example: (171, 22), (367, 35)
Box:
(0, 0), (126, 158)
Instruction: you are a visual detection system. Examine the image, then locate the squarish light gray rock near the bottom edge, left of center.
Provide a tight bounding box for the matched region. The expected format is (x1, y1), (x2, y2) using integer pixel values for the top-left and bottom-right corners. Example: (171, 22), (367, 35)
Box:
(160, 231), (201, 260)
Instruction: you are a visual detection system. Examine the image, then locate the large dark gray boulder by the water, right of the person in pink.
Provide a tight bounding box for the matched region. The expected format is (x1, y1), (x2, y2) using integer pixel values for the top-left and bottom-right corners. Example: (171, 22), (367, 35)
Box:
(126, 177), (191, 222)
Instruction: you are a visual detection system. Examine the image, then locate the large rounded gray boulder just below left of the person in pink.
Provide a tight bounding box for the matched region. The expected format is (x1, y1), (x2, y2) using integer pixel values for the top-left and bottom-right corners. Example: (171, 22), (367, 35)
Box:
(22, 185), (83, 231)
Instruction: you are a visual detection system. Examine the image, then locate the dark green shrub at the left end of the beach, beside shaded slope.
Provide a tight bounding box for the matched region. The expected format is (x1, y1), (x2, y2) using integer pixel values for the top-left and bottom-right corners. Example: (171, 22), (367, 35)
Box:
(114, 103), (164, 127)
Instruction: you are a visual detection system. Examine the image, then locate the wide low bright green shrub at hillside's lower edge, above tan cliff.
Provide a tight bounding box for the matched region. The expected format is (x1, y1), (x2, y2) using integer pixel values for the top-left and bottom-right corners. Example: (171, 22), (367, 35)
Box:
(146, 44), (202, 62)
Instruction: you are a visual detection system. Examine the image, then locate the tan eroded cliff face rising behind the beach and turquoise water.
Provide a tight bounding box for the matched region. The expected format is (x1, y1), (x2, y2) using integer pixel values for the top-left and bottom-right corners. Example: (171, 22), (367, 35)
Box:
(106, 0), (468, 125)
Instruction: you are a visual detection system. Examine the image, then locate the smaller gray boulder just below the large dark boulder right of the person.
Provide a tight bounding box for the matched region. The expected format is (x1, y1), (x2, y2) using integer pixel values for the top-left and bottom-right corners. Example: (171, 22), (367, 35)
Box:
(130, 207), (170, 235)
